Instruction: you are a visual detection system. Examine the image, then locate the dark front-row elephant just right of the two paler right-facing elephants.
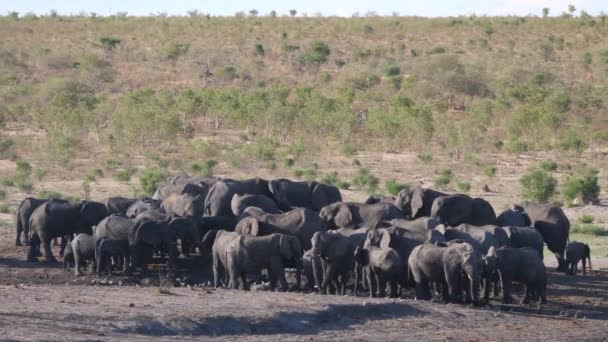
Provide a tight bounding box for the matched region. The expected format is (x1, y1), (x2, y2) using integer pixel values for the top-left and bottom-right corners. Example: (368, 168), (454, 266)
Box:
(310, 230), (365, 295)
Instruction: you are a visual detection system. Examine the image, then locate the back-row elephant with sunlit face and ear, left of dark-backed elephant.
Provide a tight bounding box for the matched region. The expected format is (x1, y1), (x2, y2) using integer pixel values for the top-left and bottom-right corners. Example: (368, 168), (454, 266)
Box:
(395, 186), (447, 220)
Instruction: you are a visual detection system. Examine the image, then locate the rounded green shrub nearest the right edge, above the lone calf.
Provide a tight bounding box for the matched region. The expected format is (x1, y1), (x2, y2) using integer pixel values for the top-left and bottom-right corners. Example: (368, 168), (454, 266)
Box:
(562, 169), (600, 204)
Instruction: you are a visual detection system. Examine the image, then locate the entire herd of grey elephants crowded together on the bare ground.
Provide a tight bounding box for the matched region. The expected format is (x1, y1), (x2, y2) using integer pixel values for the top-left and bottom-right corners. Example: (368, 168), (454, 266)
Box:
(16, 175), (591, 304)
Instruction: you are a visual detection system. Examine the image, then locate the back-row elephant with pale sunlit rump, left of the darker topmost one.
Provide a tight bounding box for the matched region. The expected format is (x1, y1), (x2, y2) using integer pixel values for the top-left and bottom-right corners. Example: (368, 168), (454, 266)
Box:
(204, 178), (272, 216)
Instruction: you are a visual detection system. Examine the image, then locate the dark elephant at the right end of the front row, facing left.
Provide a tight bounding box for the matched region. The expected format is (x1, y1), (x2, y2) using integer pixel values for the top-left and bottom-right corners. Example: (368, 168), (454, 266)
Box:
(496, 247), (547, 304)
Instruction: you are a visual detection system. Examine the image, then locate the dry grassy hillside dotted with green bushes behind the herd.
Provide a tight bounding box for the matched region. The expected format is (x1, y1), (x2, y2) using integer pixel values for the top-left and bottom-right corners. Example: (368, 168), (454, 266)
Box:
(0, 16), (608, 199)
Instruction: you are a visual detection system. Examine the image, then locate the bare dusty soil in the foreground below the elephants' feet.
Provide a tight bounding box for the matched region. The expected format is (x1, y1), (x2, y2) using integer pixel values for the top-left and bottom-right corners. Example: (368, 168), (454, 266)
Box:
(0, 227), (608, 341)
